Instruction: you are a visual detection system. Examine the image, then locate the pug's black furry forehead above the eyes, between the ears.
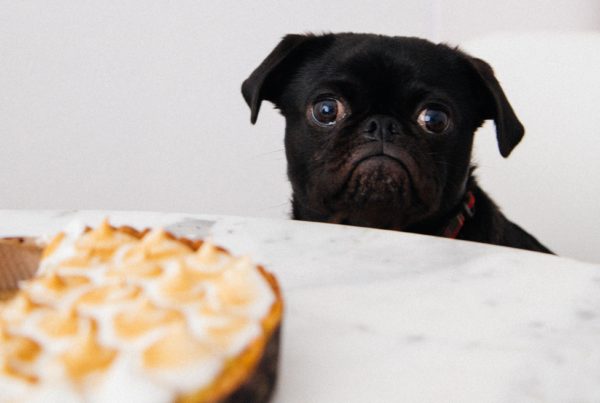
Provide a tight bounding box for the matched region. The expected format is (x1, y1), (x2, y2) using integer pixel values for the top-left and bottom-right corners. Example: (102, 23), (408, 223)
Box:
(294, 36), (469, 108)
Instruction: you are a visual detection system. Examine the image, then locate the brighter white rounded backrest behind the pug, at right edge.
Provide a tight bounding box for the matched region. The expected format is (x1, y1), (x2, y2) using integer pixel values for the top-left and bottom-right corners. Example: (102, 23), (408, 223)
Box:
(464, 31), (600, 262)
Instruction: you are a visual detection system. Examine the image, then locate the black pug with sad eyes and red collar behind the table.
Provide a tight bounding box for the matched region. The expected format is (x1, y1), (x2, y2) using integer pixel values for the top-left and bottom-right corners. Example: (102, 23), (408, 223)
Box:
(242, 33), (552, 253)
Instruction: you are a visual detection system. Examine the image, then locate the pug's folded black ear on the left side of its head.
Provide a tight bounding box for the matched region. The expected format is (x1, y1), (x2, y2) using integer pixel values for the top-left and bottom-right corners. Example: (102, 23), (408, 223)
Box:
(242, 35), (316, 124)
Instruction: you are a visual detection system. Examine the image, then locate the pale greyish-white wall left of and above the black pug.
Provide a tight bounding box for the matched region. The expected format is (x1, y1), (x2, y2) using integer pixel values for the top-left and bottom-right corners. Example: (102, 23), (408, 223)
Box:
(0, 0), (600, 260)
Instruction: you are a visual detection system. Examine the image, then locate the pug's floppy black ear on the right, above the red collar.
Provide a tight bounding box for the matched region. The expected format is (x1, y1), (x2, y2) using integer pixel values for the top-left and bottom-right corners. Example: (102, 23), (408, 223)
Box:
(468, 56), (525, 158)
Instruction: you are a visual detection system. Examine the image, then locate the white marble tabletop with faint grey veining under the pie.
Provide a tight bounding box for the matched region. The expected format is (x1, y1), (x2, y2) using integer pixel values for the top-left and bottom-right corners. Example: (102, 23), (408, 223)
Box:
(0, 210), (600, 403)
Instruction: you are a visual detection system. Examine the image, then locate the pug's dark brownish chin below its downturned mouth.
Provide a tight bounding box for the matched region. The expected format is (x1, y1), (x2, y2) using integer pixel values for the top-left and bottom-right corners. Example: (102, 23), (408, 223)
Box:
(328, 155), (413, 229)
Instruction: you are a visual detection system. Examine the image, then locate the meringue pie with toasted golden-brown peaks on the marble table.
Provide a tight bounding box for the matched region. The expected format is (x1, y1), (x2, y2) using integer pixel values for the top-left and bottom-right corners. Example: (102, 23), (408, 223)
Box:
(0, 221), (283, 403)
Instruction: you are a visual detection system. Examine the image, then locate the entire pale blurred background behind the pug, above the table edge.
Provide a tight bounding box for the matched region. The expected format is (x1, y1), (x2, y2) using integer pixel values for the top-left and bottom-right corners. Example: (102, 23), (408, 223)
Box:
(0, 0), (600, 262)
